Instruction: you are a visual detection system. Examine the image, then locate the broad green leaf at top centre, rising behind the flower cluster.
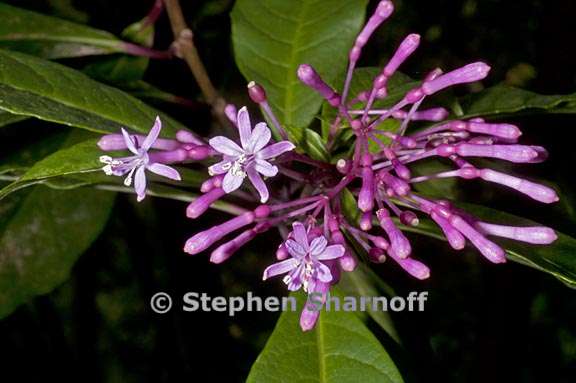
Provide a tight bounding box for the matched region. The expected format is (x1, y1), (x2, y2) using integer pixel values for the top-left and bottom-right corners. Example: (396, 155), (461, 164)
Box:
(232, 0), (367, 134)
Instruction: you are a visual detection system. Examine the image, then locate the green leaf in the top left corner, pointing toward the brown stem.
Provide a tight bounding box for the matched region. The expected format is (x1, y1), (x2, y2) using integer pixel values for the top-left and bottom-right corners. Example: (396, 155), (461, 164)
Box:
(0, 3), (124, 59)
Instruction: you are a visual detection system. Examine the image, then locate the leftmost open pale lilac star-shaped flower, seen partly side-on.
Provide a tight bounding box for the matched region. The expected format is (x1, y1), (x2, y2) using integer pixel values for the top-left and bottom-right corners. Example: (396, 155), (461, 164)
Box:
(100, 117), (180, 202)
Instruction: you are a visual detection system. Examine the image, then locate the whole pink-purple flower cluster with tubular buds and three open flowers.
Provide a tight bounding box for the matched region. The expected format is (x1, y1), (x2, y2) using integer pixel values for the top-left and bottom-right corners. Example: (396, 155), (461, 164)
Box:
(99, 0), (558, 330)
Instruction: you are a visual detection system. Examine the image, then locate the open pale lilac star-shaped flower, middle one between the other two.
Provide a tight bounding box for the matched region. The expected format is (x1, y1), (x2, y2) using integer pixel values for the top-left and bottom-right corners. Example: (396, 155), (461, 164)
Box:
(208, 107), (294, 203)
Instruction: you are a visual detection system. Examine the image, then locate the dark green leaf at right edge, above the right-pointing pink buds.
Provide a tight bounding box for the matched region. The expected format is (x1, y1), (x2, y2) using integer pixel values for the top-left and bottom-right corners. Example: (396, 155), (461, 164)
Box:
(462, 85), (576, 118)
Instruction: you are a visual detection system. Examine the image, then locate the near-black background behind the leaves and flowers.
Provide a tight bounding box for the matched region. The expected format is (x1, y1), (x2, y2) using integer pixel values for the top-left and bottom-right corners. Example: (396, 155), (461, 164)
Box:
(0, 0), (576, 382)
